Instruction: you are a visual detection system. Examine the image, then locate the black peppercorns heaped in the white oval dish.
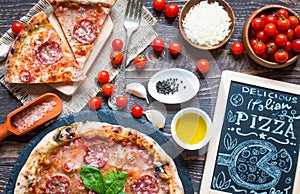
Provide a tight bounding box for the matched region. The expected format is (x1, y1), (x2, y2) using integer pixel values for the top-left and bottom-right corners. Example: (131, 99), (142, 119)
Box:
(156, 78), (186, 95)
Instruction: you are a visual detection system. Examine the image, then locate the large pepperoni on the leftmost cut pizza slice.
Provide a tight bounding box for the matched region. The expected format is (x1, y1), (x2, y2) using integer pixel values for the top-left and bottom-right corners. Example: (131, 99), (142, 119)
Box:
(37, 41), (62, 65)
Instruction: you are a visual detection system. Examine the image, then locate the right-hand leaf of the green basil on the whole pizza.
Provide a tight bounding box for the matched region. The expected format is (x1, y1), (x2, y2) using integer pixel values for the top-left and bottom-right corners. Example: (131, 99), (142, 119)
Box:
(103, 170), (128, 194)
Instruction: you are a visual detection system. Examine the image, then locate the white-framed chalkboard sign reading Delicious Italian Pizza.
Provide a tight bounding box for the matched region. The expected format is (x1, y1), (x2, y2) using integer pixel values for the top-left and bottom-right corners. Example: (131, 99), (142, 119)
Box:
(200, 71), (300, 194)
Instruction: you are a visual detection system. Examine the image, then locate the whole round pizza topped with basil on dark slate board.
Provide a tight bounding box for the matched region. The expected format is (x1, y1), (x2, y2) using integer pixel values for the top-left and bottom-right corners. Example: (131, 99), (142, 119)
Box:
(14, 121), (184, 194)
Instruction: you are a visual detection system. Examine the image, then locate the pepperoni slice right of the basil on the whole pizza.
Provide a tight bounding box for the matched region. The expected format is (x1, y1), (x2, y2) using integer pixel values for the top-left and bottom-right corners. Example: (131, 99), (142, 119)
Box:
(131, 175), (159, 194)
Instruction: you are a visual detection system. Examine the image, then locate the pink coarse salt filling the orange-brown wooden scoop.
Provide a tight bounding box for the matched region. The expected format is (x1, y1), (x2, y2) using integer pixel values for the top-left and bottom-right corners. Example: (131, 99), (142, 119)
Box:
(12, 101), (56, 132)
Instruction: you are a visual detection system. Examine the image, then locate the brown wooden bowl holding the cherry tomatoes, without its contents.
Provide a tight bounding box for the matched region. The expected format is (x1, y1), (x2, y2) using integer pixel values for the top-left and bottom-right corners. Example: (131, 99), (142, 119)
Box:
(243, 5), (299, 69)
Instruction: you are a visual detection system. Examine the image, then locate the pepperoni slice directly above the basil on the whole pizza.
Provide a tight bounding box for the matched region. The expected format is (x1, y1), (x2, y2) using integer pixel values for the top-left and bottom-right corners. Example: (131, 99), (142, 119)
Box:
(84, 141), (109, 168)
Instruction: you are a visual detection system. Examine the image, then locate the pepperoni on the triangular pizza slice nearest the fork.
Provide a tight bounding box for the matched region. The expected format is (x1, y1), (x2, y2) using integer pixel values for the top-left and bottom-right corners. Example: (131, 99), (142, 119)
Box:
(73, 19), (98, 44)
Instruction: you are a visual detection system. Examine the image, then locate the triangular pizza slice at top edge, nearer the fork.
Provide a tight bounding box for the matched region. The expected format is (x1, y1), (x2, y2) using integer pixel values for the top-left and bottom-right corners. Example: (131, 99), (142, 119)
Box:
(50, 0), (115, 68)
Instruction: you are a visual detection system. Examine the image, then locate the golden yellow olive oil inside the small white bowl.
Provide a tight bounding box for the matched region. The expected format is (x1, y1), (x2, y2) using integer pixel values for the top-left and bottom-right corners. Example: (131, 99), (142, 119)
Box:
(175, 113), (207, 144)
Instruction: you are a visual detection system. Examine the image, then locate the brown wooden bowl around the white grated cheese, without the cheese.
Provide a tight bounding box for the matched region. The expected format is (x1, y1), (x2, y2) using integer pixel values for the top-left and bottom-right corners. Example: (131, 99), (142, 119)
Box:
(179, 0), (236, 50)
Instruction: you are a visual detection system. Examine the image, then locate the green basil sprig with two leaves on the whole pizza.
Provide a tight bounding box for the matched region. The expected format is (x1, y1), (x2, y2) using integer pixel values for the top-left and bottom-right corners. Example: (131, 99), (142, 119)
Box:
(80, 166), (128, 194)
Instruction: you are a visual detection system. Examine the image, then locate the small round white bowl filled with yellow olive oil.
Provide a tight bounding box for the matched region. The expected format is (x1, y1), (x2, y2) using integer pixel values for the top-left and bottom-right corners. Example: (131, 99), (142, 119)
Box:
(171, 107), (211, 150)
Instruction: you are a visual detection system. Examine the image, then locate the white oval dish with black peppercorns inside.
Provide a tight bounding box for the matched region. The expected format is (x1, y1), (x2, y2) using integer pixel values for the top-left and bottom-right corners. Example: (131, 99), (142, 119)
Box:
(148, 68), (200, 104)
